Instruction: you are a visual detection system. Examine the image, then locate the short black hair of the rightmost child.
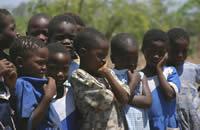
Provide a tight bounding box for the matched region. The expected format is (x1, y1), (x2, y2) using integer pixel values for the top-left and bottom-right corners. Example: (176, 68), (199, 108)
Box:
(167, 28), (190, 45)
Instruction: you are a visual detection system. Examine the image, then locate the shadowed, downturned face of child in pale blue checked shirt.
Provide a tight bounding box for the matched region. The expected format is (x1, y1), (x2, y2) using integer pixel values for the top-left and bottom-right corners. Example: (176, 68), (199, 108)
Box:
(111, 47), (138, 71)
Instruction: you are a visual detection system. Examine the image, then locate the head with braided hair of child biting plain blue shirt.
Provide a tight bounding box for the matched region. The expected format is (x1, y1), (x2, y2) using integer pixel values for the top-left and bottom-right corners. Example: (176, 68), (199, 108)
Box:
(10, 36), (48, 78)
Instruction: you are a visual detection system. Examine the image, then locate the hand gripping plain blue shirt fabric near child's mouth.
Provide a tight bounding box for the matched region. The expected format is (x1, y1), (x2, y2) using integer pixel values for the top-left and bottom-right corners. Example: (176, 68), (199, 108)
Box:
(43, 77), (56, 101)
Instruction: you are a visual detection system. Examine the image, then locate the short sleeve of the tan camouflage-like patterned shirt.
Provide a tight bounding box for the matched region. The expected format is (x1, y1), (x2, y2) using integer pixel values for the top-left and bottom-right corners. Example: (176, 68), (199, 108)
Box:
(71, 71), (114, 110)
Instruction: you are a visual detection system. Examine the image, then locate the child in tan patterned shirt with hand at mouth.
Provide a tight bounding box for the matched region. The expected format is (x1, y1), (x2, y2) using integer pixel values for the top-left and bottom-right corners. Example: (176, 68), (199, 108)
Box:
(71, 28), (129, 130)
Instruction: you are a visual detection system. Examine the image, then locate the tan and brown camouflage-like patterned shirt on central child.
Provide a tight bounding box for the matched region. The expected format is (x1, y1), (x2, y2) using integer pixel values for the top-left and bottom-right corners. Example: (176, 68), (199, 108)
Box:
(71, 69), (129, 130)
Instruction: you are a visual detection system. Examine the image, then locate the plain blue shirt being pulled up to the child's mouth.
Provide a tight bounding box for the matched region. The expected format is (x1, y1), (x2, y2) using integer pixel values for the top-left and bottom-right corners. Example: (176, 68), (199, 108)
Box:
(15, 77), (61, 130)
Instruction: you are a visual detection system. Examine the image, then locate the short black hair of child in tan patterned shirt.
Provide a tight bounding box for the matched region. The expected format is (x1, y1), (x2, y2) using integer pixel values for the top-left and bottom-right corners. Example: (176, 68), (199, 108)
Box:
(74, 28), (106, 54)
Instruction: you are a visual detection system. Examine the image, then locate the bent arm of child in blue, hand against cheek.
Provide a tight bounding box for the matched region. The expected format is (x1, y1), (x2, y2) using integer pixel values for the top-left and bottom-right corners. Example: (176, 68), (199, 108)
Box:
(156, 54), (176, 100)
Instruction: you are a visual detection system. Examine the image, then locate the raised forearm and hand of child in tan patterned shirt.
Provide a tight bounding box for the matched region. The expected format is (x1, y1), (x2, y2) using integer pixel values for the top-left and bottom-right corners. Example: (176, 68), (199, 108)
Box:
(99, 67), (130, 104)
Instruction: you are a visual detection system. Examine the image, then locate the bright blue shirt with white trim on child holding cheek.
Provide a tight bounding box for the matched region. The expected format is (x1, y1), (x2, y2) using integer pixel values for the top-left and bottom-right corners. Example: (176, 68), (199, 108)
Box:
(147, 67), (180, 130)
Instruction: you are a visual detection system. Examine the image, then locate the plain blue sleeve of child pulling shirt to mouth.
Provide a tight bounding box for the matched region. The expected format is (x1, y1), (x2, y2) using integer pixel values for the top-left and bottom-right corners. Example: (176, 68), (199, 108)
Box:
(15, 80), (38, 118)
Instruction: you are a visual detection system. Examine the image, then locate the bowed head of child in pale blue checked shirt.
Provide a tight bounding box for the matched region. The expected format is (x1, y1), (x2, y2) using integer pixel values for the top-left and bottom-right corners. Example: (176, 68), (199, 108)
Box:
(111, 33), (138, 70)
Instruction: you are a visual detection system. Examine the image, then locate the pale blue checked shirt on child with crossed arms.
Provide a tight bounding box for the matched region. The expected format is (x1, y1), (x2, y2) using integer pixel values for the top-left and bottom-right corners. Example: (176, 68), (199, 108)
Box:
(113, 69), (150, 130)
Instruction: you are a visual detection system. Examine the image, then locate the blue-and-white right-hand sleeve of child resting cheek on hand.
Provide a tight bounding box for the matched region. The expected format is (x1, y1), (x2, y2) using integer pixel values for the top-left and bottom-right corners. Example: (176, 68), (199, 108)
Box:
(167, 67), (181, 93)
